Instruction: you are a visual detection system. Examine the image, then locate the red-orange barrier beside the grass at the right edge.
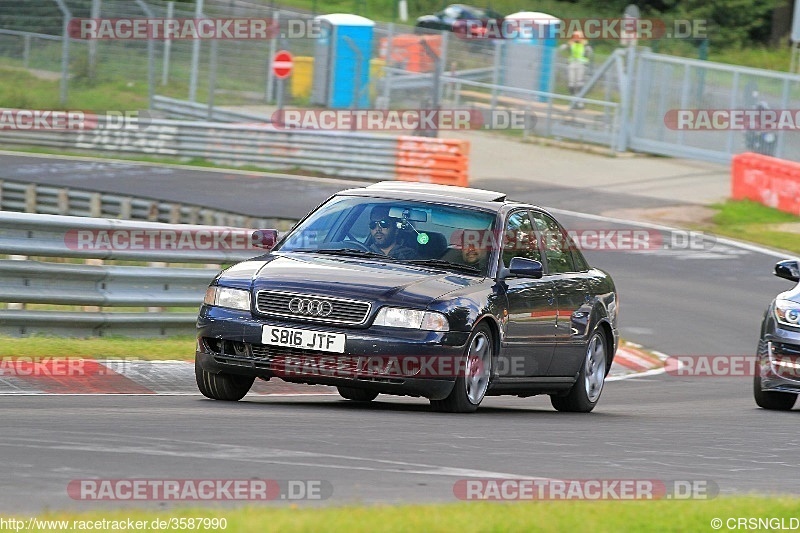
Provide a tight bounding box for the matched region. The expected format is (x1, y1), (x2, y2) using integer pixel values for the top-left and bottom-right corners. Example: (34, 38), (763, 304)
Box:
(731, 152), (800, 215)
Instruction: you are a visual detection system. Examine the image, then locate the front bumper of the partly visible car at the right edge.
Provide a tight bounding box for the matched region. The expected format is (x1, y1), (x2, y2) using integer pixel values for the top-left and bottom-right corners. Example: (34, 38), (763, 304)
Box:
(759, 328), (800, 393)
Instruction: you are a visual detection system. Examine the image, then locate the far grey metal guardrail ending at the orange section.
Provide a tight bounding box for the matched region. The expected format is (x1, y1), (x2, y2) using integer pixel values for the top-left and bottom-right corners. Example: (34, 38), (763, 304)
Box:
(0, 117), (398, 180)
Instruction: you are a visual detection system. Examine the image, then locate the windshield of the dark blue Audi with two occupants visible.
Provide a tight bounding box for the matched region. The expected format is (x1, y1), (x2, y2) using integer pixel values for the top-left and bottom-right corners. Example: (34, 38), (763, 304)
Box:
(275, 196), (496, 275)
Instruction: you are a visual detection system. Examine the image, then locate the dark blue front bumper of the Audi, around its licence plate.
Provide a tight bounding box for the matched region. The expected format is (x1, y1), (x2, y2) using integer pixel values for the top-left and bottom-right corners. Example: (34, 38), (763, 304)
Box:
(196, 307), (469, 399)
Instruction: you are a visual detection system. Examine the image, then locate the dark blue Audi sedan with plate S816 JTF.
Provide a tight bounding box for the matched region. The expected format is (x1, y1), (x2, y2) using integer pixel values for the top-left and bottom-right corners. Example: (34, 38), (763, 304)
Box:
(195, 181), (619, 412)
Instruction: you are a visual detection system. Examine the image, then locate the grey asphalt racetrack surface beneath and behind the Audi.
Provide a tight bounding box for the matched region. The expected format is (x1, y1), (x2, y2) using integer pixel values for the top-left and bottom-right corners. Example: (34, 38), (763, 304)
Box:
(0, 155), (800, 512)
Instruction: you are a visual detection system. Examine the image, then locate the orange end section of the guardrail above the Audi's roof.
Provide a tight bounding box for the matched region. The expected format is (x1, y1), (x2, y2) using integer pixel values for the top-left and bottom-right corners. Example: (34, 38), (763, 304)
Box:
(395, 136), (469, 187)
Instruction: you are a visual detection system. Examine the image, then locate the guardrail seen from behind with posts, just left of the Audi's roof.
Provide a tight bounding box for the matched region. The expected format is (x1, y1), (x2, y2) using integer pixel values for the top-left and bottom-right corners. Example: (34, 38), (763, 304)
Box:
(0, 179), (295, 230)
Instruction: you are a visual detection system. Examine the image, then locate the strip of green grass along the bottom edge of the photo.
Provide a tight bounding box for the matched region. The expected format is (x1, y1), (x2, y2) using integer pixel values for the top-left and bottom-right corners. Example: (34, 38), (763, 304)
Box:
(15, 498), (800, 533)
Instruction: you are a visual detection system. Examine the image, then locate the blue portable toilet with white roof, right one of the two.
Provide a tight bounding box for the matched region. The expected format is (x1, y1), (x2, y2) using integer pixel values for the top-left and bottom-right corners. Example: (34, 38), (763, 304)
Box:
(503, 11), (562, 101)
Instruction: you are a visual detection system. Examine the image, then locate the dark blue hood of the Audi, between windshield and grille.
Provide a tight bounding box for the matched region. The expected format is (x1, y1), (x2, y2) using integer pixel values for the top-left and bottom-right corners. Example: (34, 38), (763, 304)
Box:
(219, 253), (483, 307)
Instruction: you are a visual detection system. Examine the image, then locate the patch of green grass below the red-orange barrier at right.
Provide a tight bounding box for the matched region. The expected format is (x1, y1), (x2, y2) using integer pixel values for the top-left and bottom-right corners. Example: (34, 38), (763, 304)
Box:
(699, 200), (800, 254)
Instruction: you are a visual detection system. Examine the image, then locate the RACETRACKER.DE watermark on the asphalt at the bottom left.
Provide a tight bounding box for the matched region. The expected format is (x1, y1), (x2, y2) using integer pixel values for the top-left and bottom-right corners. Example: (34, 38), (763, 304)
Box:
(67, 479), (333, 501)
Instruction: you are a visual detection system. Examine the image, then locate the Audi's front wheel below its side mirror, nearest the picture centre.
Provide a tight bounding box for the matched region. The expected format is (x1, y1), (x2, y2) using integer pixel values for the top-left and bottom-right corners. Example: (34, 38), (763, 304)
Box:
(431, 324), (494, 413)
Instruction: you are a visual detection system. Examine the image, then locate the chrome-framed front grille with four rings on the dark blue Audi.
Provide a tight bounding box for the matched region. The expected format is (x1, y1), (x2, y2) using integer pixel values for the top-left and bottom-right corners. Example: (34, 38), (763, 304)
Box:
(256, 291), (371, 325)
